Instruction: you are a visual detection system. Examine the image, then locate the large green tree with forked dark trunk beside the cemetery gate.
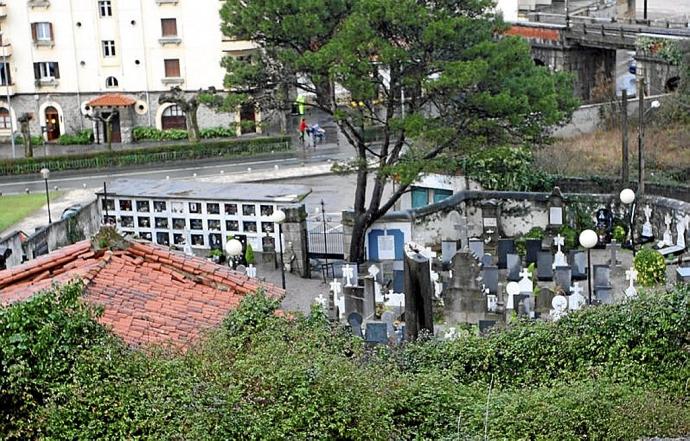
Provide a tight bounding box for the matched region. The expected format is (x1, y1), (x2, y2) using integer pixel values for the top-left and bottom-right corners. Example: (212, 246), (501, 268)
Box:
(221, 0), (576, 260)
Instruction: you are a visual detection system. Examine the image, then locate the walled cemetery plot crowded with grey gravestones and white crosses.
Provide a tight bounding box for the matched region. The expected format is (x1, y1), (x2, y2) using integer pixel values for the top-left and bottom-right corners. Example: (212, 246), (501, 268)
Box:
(330, 187), (690, 338)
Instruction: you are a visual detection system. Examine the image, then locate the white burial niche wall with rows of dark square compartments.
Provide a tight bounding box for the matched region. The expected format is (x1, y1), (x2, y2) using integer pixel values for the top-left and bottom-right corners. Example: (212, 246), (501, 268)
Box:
(97, 179), (311, 252)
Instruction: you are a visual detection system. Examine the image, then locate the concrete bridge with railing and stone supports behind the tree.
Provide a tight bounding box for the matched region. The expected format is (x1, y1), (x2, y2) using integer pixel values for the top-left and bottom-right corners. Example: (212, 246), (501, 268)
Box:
(507, 13), (690, 102)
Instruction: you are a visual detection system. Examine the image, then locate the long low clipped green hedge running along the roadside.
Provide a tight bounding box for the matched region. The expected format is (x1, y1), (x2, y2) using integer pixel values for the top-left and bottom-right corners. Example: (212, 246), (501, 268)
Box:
(0, 136), (290, 176)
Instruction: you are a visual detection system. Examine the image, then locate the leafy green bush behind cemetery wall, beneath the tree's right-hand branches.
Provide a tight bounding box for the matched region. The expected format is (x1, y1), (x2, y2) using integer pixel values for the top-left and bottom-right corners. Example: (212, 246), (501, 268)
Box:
(465, 146), (554, 191)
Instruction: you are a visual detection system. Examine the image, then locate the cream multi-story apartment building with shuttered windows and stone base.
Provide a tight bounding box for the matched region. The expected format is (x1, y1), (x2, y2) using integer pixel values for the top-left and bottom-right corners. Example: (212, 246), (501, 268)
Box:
(0, 0), (259, 142)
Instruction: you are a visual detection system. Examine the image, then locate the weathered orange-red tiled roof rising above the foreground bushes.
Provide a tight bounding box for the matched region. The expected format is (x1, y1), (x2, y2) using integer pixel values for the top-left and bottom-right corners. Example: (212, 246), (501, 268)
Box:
(0, 240), (284, 348)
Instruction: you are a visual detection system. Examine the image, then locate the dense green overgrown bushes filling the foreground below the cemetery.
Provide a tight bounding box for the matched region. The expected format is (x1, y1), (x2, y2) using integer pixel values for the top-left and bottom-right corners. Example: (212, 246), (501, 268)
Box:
(5, 287), (690, 440)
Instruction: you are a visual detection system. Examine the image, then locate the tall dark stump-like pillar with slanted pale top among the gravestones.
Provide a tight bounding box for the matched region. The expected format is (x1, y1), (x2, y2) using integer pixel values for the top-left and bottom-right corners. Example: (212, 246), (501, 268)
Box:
(404, 242), (434, 340)
